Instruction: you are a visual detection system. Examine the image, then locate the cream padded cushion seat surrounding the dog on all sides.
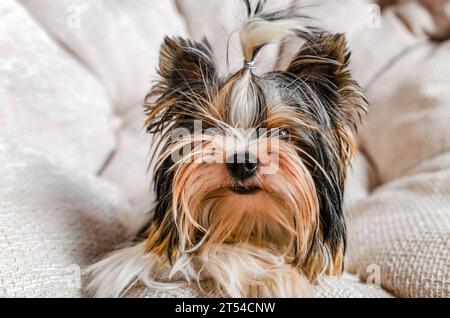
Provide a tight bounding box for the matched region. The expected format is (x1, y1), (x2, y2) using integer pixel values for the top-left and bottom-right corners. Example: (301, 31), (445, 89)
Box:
(0, 0), (450, 297)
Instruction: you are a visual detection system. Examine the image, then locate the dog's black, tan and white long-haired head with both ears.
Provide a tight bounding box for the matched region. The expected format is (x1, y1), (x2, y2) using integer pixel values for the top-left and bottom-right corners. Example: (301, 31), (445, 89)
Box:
(146, 28), (365, 280)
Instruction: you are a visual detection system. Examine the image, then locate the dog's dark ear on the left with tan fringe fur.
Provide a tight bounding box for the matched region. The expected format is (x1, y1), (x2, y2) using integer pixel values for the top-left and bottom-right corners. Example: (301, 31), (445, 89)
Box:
(144, 37), (219, 132)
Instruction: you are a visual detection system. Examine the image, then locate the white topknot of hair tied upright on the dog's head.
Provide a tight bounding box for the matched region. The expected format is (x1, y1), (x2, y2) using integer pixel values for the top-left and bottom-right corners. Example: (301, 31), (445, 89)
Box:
(225, 0), (319, 128)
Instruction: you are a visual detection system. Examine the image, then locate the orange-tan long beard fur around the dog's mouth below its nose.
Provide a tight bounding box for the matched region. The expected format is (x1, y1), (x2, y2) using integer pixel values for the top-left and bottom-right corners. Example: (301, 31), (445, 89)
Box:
(172, 142), (318, 262)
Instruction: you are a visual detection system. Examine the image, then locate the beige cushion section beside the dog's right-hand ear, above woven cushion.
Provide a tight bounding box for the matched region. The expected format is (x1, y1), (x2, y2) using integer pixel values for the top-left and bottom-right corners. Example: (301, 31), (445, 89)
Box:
(362, 42), (450, 183)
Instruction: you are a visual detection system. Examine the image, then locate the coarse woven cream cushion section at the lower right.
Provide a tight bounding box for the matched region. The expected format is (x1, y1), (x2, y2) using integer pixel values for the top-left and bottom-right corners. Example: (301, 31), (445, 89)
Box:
(346, 169), (450, 298)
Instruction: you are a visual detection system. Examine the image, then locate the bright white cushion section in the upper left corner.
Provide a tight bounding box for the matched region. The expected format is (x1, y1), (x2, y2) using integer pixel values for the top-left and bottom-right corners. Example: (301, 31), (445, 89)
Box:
(0, 0), (114, 172)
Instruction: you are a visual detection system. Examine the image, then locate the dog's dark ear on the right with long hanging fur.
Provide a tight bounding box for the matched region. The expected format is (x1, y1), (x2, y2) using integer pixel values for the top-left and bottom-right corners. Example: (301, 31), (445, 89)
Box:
(286, 34), (367, 164)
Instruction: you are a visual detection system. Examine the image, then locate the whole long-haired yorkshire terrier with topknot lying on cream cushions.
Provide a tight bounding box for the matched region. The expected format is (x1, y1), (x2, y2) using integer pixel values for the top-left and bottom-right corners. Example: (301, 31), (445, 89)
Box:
(87, 1), (366, 297)
